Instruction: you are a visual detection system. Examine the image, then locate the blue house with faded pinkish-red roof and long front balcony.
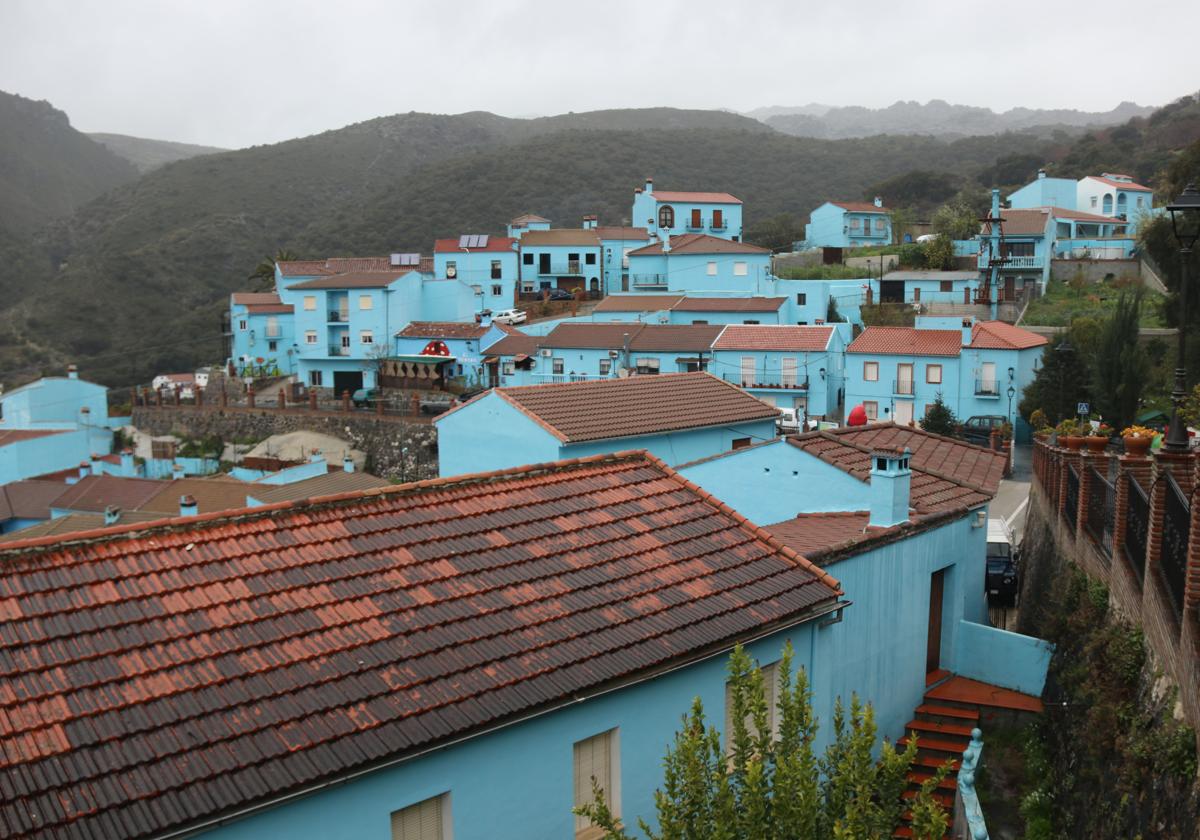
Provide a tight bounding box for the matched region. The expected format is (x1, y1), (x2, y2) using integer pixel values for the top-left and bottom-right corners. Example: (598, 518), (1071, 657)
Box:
(708, 324), (846, 420)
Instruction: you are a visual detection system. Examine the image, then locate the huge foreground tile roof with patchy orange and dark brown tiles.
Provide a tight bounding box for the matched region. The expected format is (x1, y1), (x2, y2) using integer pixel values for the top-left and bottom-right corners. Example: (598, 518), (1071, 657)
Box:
(0, 452), (840, 840)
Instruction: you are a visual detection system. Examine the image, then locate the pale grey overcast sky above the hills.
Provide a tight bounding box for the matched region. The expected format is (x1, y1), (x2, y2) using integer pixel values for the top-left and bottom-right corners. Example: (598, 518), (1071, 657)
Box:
(0, 0), (1200, 148)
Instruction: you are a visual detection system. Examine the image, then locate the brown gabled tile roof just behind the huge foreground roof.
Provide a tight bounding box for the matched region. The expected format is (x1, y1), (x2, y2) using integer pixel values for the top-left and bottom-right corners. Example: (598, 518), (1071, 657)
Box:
(458, 373), (779, 444)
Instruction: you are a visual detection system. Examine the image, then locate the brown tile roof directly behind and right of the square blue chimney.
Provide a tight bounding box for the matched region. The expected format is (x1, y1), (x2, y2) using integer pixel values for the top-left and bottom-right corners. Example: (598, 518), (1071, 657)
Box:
(787, 422), (1004, 512)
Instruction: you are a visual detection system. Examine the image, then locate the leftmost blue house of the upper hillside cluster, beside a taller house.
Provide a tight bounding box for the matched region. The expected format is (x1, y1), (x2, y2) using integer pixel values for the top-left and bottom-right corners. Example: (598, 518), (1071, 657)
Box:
(229, 292), (300, 376)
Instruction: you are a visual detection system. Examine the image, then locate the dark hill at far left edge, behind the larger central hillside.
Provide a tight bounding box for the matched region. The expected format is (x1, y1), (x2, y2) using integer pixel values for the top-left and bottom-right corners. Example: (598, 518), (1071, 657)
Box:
(0, 91), (138, 235)
